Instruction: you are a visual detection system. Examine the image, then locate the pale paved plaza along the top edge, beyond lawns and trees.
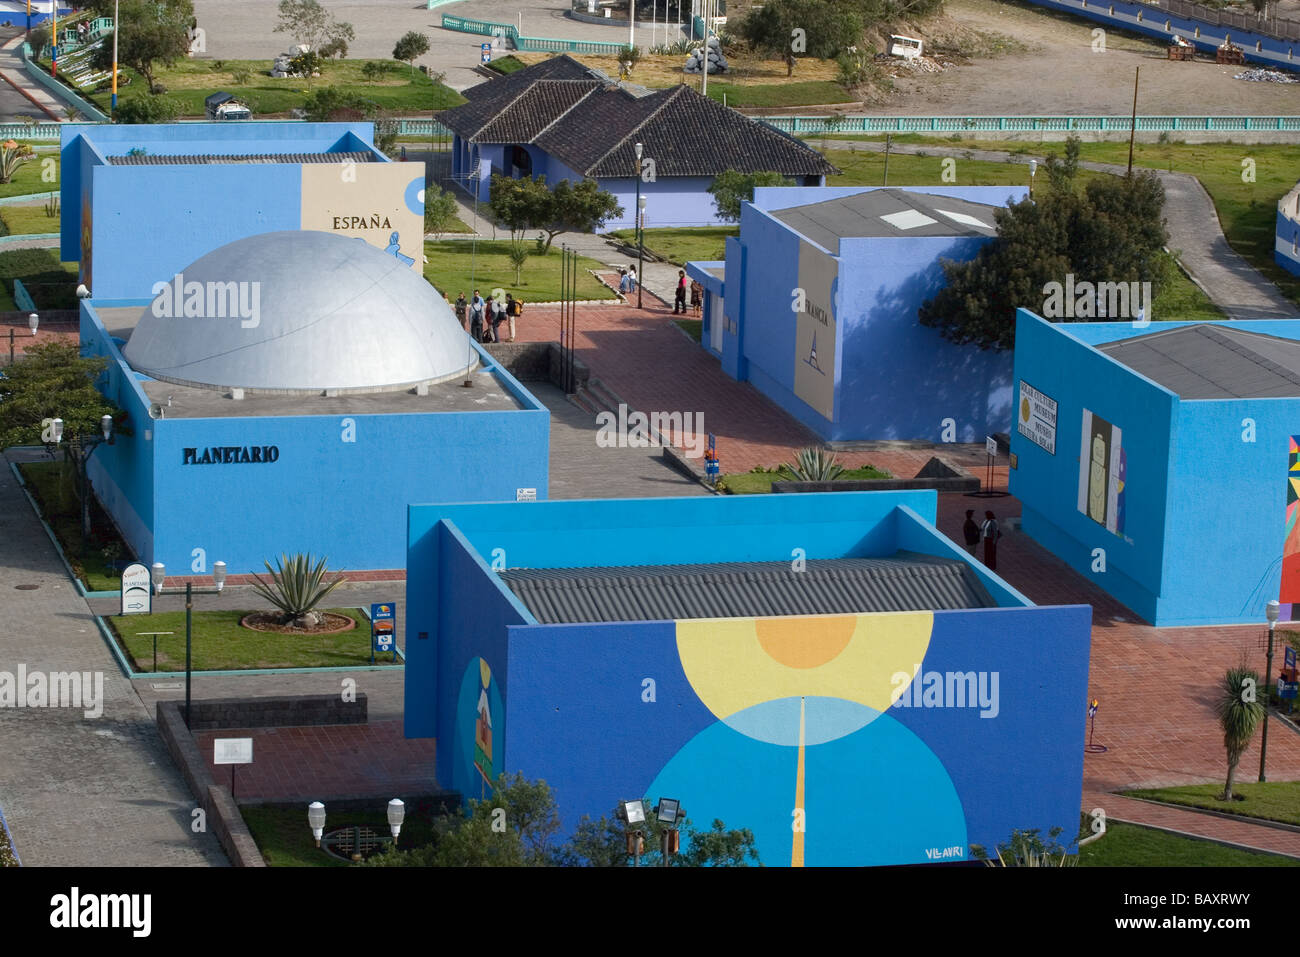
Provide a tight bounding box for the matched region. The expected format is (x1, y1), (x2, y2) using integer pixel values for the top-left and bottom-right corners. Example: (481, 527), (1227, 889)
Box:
(194, 0), (681, 90)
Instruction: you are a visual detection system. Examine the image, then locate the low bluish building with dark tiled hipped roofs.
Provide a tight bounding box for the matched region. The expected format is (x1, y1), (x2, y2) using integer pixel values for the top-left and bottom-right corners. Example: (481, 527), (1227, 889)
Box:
(438, 55), (839, 229)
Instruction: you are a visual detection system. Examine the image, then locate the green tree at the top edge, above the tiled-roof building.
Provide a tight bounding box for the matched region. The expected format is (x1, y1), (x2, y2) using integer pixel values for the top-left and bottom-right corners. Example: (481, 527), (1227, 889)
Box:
(736, 0), (876, 77)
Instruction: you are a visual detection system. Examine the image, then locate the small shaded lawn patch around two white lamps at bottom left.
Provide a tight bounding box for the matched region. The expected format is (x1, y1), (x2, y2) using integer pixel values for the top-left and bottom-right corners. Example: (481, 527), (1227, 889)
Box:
(239, 801), (444, 867)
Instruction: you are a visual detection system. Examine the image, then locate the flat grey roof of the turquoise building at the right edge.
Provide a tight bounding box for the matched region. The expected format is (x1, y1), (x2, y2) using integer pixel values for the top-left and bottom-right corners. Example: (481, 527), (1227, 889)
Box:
(1097, 324), (1300, 399)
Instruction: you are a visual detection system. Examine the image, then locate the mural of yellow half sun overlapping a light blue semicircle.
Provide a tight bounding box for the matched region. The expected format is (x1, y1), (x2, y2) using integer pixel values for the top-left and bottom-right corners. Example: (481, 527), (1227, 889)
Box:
(647, 612), (966, 867)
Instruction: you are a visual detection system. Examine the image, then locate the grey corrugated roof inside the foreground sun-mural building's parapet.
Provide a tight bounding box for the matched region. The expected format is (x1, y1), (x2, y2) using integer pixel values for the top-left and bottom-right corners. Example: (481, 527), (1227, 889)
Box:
(501, 551), (996, 624)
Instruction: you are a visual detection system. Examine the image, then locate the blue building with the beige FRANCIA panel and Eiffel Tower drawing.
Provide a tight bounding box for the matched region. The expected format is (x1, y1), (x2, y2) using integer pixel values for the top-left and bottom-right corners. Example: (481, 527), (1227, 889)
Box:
(688, 186), (1027, 442)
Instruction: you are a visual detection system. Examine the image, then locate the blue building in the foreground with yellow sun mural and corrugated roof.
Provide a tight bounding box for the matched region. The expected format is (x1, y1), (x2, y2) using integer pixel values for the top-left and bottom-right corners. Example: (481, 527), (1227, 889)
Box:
(406, 492), (1091, 866)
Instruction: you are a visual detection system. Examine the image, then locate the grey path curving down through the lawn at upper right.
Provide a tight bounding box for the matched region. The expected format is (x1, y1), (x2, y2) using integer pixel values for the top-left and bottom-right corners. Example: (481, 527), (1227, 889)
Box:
(854, 142), (1300, 319)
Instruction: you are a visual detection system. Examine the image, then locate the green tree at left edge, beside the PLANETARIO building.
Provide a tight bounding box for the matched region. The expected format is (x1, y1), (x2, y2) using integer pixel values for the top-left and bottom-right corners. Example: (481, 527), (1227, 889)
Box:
(0, 342), (121, 449)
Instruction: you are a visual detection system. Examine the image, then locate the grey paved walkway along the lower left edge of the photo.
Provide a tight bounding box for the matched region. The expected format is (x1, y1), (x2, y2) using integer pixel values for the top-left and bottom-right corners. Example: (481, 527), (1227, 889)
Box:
(0, 459), (225, 867)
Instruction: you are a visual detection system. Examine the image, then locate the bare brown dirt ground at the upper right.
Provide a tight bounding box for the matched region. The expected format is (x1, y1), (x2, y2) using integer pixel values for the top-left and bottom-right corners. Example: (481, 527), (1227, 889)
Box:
(870, 0), (1300, 116)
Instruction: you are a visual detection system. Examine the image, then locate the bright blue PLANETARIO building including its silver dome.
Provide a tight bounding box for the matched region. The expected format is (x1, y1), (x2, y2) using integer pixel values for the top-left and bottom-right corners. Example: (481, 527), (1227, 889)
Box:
(81, 230), (550, 575)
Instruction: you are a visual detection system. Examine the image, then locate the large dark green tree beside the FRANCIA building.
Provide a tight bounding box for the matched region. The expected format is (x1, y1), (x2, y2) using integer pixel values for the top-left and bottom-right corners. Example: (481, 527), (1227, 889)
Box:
(918, 170), (1167, 350)
